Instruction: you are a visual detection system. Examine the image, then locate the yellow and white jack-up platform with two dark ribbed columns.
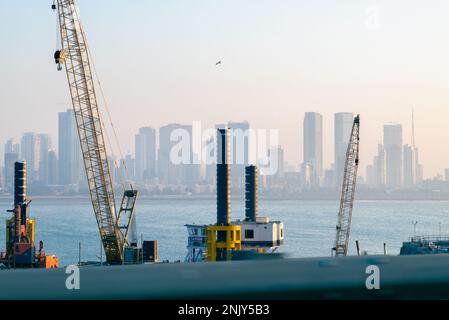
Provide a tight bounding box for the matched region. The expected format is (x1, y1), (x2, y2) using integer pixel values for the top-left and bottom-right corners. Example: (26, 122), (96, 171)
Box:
(185, 128), (284, 262)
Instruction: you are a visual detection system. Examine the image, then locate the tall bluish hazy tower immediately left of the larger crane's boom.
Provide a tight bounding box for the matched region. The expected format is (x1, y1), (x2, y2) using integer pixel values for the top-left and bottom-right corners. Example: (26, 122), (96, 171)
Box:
(58, 109), (83, 185)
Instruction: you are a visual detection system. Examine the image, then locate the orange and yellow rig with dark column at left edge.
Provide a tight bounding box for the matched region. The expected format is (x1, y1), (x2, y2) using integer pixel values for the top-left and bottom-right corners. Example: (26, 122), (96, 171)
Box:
(0, 161), (59, 269)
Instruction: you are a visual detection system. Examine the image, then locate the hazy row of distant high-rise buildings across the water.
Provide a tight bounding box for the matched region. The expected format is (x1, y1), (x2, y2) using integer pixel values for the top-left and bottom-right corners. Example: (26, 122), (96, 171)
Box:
(0, 109), (430, 182)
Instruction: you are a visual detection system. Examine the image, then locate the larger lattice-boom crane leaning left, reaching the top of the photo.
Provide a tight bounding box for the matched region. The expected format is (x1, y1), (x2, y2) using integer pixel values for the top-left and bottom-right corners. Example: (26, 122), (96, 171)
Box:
(52, 0), (138, 264)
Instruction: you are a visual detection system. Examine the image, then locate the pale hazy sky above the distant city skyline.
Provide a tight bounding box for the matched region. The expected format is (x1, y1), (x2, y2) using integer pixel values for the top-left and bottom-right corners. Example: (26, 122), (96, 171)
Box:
(0, 0), (449, 177)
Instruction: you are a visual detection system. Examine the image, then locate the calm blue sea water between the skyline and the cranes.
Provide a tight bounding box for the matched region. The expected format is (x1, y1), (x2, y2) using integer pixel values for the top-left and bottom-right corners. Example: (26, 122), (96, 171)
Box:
(0, 199), (449, 265)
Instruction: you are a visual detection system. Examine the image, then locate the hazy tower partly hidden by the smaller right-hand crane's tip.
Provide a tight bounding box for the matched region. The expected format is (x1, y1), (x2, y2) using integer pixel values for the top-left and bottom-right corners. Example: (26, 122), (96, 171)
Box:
(334, 112), (354, 186)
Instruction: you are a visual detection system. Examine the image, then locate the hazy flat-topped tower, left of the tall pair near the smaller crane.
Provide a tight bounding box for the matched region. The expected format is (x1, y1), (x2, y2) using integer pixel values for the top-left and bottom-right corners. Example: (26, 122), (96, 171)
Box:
(303, 112), (323, 186)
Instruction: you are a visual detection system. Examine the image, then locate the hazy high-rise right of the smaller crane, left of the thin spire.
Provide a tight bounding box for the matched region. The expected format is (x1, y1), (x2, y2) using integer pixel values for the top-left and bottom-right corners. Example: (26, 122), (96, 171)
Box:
(384, 123), (403, 188)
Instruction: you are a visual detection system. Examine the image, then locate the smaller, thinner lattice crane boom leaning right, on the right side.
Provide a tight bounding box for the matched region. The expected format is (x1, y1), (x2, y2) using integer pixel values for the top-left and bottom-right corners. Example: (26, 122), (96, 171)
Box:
(332, 115), (360, 256)
